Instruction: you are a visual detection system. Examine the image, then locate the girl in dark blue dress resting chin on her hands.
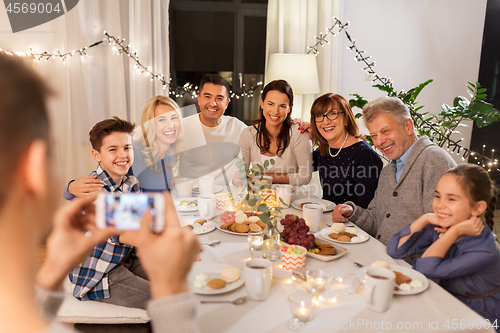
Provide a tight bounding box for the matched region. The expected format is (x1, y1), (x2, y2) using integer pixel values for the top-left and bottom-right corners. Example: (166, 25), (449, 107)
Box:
(387, 164), (500, 331)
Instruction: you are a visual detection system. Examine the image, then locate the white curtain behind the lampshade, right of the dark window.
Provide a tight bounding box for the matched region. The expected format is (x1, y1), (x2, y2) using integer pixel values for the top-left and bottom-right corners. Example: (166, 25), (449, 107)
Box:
(266, 0), (343, 121)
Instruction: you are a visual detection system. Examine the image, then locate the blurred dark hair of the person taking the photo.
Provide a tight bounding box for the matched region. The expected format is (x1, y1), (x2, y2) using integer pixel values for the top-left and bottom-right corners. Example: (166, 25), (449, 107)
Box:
(0, 53), (51, 207)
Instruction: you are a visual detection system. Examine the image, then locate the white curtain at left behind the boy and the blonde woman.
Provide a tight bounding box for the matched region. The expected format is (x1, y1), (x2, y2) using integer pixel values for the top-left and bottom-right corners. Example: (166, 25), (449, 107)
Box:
(0, 0), (170, 182)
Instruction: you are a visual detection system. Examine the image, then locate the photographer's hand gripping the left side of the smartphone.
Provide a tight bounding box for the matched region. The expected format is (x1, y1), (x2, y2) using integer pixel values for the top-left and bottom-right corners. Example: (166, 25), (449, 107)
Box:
(36, 195), (119, 290)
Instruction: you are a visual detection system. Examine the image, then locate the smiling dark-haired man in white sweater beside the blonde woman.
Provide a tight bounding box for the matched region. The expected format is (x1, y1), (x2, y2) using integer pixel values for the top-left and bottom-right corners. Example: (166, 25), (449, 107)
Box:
(179, 75), (247, 185)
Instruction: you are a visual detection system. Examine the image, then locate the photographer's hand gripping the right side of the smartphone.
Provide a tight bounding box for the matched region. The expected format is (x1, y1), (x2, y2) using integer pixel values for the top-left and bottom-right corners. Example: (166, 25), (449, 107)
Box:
(137, 192), (200, 298)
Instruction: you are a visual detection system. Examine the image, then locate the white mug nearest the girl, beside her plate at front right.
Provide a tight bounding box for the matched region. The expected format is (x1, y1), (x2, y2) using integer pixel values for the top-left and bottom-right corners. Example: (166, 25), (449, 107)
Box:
(364, 268), (396, 312)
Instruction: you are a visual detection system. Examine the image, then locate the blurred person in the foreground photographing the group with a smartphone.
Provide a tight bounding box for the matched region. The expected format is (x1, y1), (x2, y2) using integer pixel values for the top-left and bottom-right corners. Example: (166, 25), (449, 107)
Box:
(0, 54), (199, 333)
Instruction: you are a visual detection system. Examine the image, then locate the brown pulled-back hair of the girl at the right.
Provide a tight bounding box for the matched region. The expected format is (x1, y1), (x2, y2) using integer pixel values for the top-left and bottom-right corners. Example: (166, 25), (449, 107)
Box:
(445, 164), (498, 230)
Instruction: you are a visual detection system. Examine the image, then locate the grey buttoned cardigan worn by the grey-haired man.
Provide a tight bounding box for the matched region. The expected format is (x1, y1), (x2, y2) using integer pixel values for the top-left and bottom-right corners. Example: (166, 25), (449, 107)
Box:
(349, 136), (457, 245)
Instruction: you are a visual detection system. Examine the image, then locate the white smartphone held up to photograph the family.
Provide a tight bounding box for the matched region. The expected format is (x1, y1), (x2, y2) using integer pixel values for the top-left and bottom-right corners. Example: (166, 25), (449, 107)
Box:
(96, 192), (165, 231)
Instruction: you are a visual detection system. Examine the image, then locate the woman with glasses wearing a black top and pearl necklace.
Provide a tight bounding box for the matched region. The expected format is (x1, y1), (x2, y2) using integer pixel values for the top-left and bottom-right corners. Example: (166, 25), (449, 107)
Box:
(311, 93), (382, 208)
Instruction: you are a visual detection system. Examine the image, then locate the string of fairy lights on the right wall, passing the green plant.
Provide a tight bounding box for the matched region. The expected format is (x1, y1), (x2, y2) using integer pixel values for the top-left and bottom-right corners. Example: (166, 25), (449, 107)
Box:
(307, 17), (500, 172)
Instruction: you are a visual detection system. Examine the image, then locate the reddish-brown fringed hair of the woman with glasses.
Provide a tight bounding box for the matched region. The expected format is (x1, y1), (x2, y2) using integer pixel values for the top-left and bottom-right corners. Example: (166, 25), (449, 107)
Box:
(310, 93), (363, 156)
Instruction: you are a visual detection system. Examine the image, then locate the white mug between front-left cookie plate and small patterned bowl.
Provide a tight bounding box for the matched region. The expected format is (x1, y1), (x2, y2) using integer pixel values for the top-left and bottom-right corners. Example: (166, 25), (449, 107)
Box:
(243, 258), (273, 301)
